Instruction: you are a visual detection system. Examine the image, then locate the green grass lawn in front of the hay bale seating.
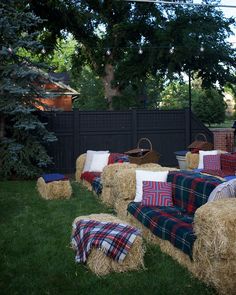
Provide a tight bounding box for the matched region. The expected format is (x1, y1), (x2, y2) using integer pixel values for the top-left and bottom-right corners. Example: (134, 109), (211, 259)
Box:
(0, 181), (215, 295)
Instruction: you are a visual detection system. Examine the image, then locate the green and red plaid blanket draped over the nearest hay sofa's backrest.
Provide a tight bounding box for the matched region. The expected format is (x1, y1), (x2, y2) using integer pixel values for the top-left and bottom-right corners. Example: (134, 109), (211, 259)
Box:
(167, 171), (222, 214)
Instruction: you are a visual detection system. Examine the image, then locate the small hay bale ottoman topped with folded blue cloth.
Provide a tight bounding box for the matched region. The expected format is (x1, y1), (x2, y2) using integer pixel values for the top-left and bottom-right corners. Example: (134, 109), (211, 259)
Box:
(37, 173), (72, 200)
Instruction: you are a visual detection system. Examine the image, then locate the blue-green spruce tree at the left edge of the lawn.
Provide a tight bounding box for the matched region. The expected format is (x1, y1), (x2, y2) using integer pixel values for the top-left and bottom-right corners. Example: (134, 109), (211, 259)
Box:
(0, 0), (55, 178)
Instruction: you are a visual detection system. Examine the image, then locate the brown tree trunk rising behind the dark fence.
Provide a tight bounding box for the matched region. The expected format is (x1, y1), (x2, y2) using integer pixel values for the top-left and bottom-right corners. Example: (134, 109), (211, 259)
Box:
(102, 63), (121, 110)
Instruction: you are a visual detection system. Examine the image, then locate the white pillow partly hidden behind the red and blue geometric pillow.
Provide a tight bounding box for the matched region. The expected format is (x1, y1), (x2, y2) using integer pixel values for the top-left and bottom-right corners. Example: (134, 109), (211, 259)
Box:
(134, 170), (169, 202)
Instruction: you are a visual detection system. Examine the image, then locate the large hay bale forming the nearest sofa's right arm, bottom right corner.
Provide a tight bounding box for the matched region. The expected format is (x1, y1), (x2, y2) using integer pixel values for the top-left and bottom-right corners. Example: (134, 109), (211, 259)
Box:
(193, 199), (236, 294)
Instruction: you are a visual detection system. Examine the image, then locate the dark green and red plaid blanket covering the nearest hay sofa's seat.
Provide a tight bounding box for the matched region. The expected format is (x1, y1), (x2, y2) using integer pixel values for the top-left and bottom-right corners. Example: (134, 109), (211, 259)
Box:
(127, 202), (196, 258)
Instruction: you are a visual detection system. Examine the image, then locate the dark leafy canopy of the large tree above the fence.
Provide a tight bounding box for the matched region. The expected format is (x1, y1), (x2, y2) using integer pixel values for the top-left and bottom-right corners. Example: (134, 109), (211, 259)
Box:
(29, 0), (235, 109)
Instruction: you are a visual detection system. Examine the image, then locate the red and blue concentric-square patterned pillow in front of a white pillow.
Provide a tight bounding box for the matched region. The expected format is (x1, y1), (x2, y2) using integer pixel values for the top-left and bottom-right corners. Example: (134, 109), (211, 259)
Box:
(142, 181), (173, 206)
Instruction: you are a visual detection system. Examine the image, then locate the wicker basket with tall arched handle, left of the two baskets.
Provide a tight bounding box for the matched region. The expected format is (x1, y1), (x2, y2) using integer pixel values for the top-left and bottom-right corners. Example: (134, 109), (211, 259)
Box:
(125, 138), (160, 165)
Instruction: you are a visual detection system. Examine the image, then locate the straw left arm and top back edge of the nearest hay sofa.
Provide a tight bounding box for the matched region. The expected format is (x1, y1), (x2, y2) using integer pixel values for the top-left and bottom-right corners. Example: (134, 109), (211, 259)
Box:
(113, 163), (178, 220)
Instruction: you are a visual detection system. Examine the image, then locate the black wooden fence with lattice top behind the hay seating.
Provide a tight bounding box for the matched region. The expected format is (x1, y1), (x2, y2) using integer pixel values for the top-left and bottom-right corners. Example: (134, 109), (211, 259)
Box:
(39, 109), (213, 174)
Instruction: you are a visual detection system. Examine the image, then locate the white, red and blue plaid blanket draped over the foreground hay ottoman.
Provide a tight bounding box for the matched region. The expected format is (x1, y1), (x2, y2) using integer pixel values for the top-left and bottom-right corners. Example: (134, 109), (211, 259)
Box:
(71, 219), (140, 262)
